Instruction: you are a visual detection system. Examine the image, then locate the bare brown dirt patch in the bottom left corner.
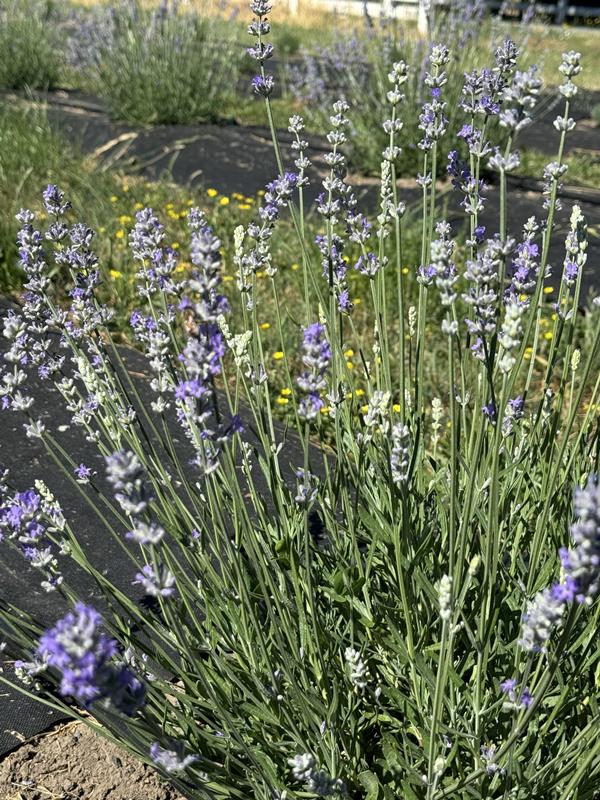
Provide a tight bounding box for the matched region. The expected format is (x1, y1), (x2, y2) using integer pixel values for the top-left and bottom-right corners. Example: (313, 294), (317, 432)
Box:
(0, 722), (184, 800)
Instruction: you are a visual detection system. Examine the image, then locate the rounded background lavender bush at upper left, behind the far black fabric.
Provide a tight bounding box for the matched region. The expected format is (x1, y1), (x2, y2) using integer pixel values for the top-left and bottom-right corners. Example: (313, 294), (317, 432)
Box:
(61, 0), (243, 124)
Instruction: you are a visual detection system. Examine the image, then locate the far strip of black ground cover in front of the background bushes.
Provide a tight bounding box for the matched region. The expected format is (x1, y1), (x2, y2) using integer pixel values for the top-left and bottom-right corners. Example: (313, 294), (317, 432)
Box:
(19, 92), (600, 298)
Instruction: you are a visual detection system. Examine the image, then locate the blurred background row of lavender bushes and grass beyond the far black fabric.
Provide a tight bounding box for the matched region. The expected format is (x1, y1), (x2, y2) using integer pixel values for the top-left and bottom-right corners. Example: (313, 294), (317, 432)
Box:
(0, 0), (598, 175)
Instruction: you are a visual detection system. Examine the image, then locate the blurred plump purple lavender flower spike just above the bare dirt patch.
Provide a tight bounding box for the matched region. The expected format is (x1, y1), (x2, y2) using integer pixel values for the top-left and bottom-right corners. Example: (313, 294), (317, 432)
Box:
(36, 603), (146, 716)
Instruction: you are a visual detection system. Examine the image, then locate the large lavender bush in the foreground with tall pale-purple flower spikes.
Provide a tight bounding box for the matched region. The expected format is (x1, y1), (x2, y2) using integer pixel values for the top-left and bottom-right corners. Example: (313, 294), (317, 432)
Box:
(0, 0), (600, 800)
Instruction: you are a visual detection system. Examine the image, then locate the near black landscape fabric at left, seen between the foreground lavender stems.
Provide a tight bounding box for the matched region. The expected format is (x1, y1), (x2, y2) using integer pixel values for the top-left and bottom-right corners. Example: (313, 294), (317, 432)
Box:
(0, 298), (312, 756)
